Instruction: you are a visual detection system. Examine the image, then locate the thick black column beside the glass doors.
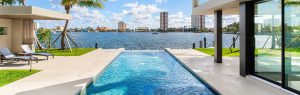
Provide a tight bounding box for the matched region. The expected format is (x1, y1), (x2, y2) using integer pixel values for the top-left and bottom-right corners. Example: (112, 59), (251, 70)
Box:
(239, 1), (255, 77)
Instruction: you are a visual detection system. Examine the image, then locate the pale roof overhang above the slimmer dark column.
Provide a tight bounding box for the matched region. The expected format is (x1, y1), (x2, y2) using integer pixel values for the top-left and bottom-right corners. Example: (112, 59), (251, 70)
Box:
(193, 0), (249, 15)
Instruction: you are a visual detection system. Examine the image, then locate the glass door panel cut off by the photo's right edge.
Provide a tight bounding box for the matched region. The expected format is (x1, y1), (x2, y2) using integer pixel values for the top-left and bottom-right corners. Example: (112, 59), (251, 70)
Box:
(284, 0), (300, 90)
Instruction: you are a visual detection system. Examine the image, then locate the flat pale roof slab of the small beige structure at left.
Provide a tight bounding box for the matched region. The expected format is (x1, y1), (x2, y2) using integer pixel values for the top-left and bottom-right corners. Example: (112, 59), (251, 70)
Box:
(0, 6), (72, 20)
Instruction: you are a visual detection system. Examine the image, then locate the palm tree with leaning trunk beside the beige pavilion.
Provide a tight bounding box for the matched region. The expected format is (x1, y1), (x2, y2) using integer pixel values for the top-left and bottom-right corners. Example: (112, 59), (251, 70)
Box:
(61, 0), (107, 49)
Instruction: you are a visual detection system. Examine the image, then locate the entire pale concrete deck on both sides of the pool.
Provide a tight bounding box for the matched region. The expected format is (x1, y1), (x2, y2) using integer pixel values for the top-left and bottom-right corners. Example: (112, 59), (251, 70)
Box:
(0, 49), (291, 95)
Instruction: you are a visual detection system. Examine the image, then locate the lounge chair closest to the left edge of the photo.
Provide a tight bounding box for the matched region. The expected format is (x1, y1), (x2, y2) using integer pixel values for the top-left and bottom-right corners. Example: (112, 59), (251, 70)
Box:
(0, 48), (38, 70)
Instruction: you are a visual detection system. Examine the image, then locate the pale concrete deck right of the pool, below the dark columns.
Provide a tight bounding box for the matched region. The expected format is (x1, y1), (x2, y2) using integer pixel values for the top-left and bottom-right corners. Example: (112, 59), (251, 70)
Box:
(166, 49), (296, 95)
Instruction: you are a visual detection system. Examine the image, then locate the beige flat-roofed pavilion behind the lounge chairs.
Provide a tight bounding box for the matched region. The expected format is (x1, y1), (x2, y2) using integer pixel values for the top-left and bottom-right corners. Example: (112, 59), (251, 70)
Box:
(0, 6), (72, 53)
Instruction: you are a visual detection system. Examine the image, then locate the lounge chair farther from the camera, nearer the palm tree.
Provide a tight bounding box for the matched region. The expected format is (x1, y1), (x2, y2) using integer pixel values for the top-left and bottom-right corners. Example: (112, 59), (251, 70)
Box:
(21, 45), (54, 60)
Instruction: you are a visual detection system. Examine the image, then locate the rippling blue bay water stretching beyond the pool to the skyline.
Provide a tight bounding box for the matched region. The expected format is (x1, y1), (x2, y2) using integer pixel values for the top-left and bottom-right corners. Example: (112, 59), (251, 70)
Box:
(49, 32), (268, 50)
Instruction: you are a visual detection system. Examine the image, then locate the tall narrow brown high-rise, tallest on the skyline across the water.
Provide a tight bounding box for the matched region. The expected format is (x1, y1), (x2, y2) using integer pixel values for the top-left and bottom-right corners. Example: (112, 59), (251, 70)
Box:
(160, 12), (168, 31)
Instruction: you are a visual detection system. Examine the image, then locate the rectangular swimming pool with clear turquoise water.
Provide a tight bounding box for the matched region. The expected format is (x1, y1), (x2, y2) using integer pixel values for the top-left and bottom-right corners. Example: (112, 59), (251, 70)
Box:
(81, 51), (218, 95)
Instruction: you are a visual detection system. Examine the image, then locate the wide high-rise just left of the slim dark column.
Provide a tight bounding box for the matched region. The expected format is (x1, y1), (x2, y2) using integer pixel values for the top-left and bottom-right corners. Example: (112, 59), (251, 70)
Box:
(191, 15), (205, 29)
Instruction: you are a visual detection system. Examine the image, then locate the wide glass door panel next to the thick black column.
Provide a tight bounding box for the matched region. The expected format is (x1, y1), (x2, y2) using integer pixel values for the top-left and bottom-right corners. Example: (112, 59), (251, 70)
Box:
(254, 0), (282, 83)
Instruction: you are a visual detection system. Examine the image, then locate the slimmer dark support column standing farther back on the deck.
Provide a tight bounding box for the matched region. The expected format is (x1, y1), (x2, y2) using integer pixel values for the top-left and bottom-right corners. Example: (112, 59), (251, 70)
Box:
(214, 10), (222, 63)
